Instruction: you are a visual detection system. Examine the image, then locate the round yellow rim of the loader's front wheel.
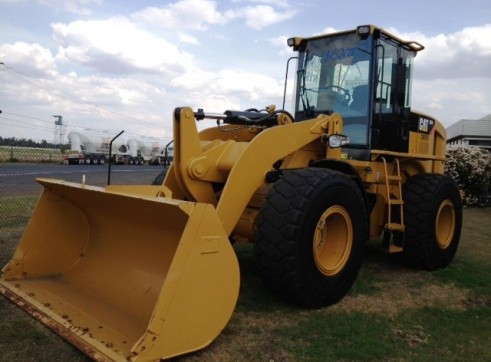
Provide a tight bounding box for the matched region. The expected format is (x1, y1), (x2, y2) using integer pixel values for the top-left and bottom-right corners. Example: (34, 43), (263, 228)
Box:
(313, 205), (353, 276)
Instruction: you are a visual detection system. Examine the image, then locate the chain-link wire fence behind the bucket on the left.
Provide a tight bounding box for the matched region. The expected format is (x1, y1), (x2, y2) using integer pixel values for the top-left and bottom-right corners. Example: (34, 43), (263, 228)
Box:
(0, 146), (164, 228)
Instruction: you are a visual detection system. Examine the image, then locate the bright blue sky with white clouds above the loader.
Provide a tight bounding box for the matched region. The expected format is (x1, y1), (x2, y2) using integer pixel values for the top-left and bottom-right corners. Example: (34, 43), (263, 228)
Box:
(0, 0), (491, 143)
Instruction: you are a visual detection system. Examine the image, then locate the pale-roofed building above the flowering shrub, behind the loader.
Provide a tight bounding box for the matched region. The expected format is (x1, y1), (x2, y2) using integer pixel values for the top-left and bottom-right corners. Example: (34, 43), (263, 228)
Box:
(447, 114), (491, 152)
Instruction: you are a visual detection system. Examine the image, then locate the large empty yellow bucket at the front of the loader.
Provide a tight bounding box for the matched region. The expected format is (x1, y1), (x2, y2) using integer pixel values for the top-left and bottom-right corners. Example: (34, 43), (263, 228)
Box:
(0, 179), (239, 361)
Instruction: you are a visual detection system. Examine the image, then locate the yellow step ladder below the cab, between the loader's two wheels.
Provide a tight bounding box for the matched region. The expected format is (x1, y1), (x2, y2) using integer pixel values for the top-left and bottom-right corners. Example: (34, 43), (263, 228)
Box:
(381, 157), (405, 253)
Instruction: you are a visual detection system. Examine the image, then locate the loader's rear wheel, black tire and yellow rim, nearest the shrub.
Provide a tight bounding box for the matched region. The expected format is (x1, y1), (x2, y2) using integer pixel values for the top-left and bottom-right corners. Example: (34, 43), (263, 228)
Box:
(402, 174), (462, 270)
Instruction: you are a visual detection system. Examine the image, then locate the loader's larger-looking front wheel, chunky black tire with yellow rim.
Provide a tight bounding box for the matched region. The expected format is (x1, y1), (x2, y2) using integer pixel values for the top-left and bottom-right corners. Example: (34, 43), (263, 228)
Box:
(254, 168), (368, 308)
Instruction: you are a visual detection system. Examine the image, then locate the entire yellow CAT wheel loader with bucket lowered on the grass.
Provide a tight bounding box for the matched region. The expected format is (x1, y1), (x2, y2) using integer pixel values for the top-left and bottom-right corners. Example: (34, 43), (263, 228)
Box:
(0, 25), (462, 361)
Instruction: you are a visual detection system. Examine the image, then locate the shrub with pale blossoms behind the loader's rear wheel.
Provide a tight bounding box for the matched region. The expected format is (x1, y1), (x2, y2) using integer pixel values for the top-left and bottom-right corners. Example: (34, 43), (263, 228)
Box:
(445, 146), (491, 206)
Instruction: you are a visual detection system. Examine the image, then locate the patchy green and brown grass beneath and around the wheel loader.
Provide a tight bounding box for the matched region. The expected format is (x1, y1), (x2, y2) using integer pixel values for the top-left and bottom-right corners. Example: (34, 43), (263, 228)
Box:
(0, 208), (491, 362)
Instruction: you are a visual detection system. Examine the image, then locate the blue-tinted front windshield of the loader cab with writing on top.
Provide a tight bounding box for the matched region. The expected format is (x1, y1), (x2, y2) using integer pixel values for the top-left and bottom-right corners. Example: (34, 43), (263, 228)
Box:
(295, 32), (373, 145)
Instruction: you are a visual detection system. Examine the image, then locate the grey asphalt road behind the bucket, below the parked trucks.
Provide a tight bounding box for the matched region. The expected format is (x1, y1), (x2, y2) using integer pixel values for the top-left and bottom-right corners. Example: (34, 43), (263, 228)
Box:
(0, 163), (163, 197)
